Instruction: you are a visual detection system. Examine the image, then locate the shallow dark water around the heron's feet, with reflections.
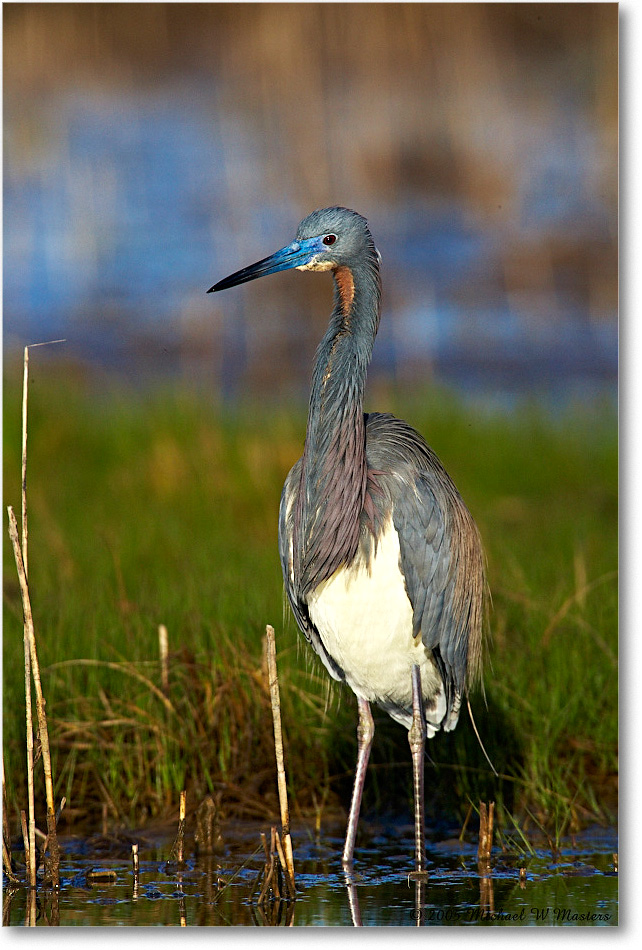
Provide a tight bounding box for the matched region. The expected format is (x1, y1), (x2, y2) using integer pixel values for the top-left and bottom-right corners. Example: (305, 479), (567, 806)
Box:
(5, 824), (618, 927)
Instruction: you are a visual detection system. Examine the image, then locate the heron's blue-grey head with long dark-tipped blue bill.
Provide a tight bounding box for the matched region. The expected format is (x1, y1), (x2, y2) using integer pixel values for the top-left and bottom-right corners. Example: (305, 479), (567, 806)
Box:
(208, 208), (378, 293)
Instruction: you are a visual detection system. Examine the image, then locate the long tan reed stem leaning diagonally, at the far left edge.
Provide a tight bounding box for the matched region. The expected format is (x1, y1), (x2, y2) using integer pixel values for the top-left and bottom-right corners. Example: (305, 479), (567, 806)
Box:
(7, 505), (60, 887)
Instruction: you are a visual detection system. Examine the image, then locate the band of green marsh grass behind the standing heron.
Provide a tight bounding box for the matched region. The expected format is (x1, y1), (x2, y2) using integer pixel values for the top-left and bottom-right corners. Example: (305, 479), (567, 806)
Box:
(3, 367), (617, 836)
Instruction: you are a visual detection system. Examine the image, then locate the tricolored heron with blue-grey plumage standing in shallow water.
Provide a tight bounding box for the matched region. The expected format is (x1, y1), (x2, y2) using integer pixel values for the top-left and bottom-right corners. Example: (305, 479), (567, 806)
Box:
(208, 208), (485, 871)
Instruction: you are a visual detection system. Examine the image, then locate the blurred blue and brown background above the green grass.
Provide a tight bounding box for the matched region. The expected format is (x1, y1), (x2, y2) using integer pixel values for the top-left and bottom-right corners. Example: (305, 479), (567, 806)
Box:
(3, 3), (618, 408)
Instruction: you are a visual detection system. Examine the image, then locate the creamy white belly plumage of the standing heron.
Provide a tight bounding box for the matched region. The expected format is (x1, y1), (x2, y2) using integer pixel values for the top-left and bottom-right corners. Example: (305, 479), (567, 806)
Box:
(308, 519), (446, 736)
